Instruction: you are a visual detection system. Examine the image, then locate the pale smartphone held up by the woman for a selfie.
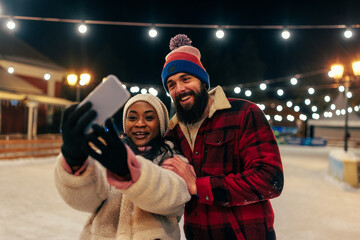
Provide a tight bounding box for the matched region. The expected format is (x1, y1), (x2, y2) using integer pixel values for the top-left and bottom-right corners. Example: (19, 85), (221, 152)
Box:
(78, 75), (131, 132)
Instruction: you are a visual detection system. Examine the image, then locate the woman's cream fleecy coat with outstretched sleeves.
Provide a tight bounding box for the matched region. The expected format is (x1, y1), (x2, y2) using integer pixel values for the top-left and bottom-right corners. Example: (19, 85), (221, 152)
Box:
(55, 144), (190, 240)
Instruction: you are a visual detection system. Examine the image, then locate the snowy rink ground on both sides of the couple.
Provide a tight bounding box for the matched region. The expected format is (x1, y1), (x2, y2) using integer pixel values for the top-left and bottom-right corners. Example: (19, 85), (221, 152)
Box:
(0, 146), (360, 240)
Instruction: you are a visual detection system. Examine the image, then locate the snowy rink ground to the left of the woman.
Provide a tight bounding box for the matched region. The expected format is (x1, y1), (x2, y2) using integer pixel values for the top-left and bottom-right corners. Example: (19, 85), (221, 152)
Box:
(0, 157), (88, 240)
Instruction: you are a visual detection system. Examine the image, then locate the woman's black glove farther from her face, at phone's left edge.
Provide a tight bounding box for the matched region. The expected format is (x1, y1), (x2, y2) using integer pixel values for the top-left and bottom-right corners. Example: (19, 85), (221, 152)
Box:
(61, 102), (97, 167)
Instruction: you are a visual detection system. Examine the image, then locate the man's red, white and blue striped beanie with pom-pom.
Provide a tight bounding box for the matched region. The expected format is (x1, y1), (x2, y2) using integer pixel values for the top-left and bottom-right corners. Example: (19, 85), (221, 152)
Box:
(161, 34), (210, 92)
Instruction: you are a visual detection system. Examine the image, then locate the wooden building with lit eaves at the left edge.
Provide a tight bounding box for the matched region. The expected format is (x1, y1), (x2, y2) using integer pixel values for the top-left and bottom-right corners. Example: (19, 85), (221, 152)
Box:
(0, 31), (72, 139)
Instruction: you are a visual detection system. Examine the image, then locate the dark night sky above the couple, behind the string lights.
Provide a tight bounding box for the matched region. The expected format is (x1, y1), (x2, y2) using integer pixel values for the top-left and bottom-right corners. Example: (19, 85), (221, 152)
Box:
(0, 0), (360, 100)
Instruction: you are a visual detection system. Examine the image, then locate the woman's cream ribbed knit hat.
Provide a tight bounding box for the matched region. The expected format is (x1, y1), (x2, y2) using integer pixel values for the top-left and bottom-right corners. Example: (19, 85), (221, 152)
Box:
(123, 94), (169, 137)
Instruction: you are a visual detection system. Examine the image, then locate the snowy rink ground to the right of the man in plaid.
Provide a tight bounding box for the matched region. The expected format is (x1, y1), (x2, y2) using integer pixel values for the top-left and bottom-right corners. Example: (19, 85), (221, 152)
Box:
(271, 146), (360, 240)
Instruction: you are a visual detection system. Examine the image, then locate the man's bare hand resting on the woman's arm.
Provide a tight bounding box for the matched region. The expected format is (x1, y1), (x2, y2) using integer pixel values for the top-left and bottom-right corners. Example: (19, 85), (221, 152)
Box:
(161, 156), (197, 195)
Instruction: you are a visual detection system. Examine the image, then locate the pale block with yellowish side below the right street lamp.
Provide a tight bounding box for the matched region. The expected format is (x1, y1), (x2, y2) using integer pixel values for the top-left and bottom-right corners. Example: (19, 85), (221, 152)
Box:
(329, 149), (360, 188)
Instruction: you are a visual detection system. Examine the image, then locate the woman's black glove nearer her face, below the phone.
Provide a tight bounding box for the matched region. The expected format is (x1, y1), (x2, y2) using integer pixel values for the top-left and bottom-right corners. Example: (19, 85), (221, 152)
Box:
(83, 118), (130, 177)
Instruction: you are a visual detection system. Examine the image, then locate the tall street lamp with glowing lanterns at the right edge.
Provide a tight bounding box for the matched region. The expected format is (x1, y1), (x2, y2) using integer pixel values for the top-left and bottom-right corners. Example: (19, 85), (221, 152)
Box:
(331, 61), (360, 152)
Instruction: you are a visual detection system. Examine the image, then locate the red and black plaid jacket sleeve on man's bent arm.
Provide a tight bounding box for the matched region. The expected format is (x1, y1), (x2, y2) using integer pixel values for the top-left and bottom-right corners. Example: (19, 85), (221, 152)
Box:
(197, 104), (283, 207)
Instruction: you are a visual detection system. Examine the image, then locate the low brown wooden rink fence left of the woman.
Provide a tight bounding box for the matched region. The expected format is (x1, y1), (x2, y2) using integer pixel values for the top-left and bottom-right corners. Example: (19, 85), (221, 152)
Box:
(0, 135), (62, 160)
